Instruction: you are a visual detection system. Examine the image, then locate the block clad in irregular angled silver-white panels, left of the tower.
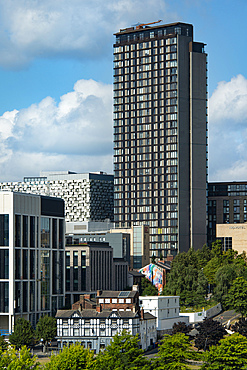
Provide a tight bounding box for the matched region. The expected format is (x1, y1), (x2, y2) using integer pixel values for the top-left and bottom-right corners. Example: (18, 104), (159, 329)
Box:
(0, 171), (113, 223)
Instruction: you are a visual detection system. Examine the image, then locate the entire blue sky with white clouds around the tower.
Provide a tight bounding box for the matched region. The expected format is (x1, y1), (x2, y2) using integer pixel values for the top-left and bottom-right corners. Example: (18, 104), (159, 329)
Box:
(0, 0), (247, 181)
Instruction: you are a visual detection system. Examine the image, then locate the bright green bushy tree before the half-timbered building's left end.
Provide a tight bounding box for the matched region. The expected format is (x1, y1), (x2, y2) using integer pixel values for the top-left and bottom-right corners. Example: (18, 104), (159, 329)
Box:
(45, 343), (95, 370)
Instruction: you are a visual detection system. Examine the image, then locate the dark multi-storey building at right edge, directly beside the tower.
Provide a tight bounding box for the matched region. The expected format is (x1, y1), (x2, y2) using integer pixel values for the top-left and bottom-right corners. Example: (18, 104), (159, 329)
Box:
(207, 181), (247, 244)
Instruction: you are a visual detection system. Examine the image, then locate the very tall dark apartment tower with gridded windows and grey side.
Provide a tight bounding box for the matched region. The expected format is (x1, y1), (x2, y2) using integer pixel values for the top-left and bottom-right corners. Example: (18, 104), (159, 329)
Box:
(114, 23), (207, 256)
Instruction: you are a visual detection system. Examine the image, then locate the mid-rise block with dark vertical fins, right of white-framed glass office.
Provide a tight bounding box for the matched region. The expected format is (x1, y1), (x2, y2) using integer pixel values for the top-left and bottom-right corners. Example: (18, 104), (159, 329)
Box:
(65, 236), (128, 306)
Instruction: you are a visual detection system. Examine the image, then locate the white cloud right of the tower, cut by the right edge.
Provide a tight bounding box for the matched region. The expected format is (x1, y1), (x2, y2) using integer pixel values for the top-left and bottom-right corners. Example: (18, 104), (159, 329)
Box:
(209, 75), (247, 181)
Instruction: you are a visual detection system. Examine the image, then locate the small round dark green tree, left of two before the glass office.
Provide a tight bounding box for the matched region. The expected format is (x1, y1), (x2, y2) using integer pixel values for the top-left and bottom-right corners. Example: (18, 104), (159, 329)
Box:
(9, 318), (34, 348)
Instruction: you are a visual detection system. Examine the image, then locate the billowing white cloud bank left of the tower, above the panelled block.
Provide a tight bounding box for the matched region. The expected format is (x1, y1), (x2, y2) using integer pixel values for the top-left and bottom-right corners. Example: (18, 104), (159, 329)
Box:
(0, 80), (112, 181)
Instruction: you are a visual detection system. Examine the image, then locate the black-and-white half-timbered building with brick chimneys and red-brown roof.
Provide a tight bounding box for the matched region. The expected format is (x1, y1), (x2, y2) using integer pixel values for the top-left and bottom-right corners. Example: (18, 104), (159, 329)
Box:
(56, 286), (157, 353)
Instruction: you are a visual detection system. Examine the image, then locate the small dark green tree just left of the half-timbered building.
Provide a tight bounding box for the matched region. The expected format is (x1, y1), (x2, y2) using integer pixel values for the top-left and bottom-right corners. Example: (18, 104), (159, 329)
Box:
(35, 315), (57, 350)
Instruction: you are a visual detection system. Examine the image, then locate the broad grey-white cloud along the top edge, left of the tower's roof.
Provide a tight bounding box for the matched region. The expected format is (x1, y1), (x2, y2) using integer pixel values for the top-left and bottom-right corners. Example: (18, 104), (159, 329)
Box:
(0, 0), (177, 68)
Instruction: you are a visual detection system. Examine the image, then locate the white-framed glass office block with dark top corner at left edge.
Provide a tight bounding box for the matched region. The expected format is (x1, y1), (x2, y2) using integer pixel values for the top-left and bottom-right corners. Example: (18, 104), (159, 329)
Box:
(0, 191), (65, 333)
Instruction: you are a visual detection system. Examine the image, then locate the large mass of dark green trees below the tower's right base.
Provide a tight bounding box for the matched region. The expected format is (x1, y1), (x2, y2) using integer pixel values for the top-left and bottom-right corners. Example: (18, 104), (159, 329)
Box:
(162, 240), (247, 309)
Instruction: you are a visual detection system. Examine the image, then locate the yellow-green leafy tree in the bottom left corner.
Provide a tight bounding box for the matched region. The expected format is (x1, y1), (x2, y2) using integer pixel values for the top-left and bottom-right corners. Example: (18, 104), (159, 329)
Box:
(0, 346), (40, 370)
